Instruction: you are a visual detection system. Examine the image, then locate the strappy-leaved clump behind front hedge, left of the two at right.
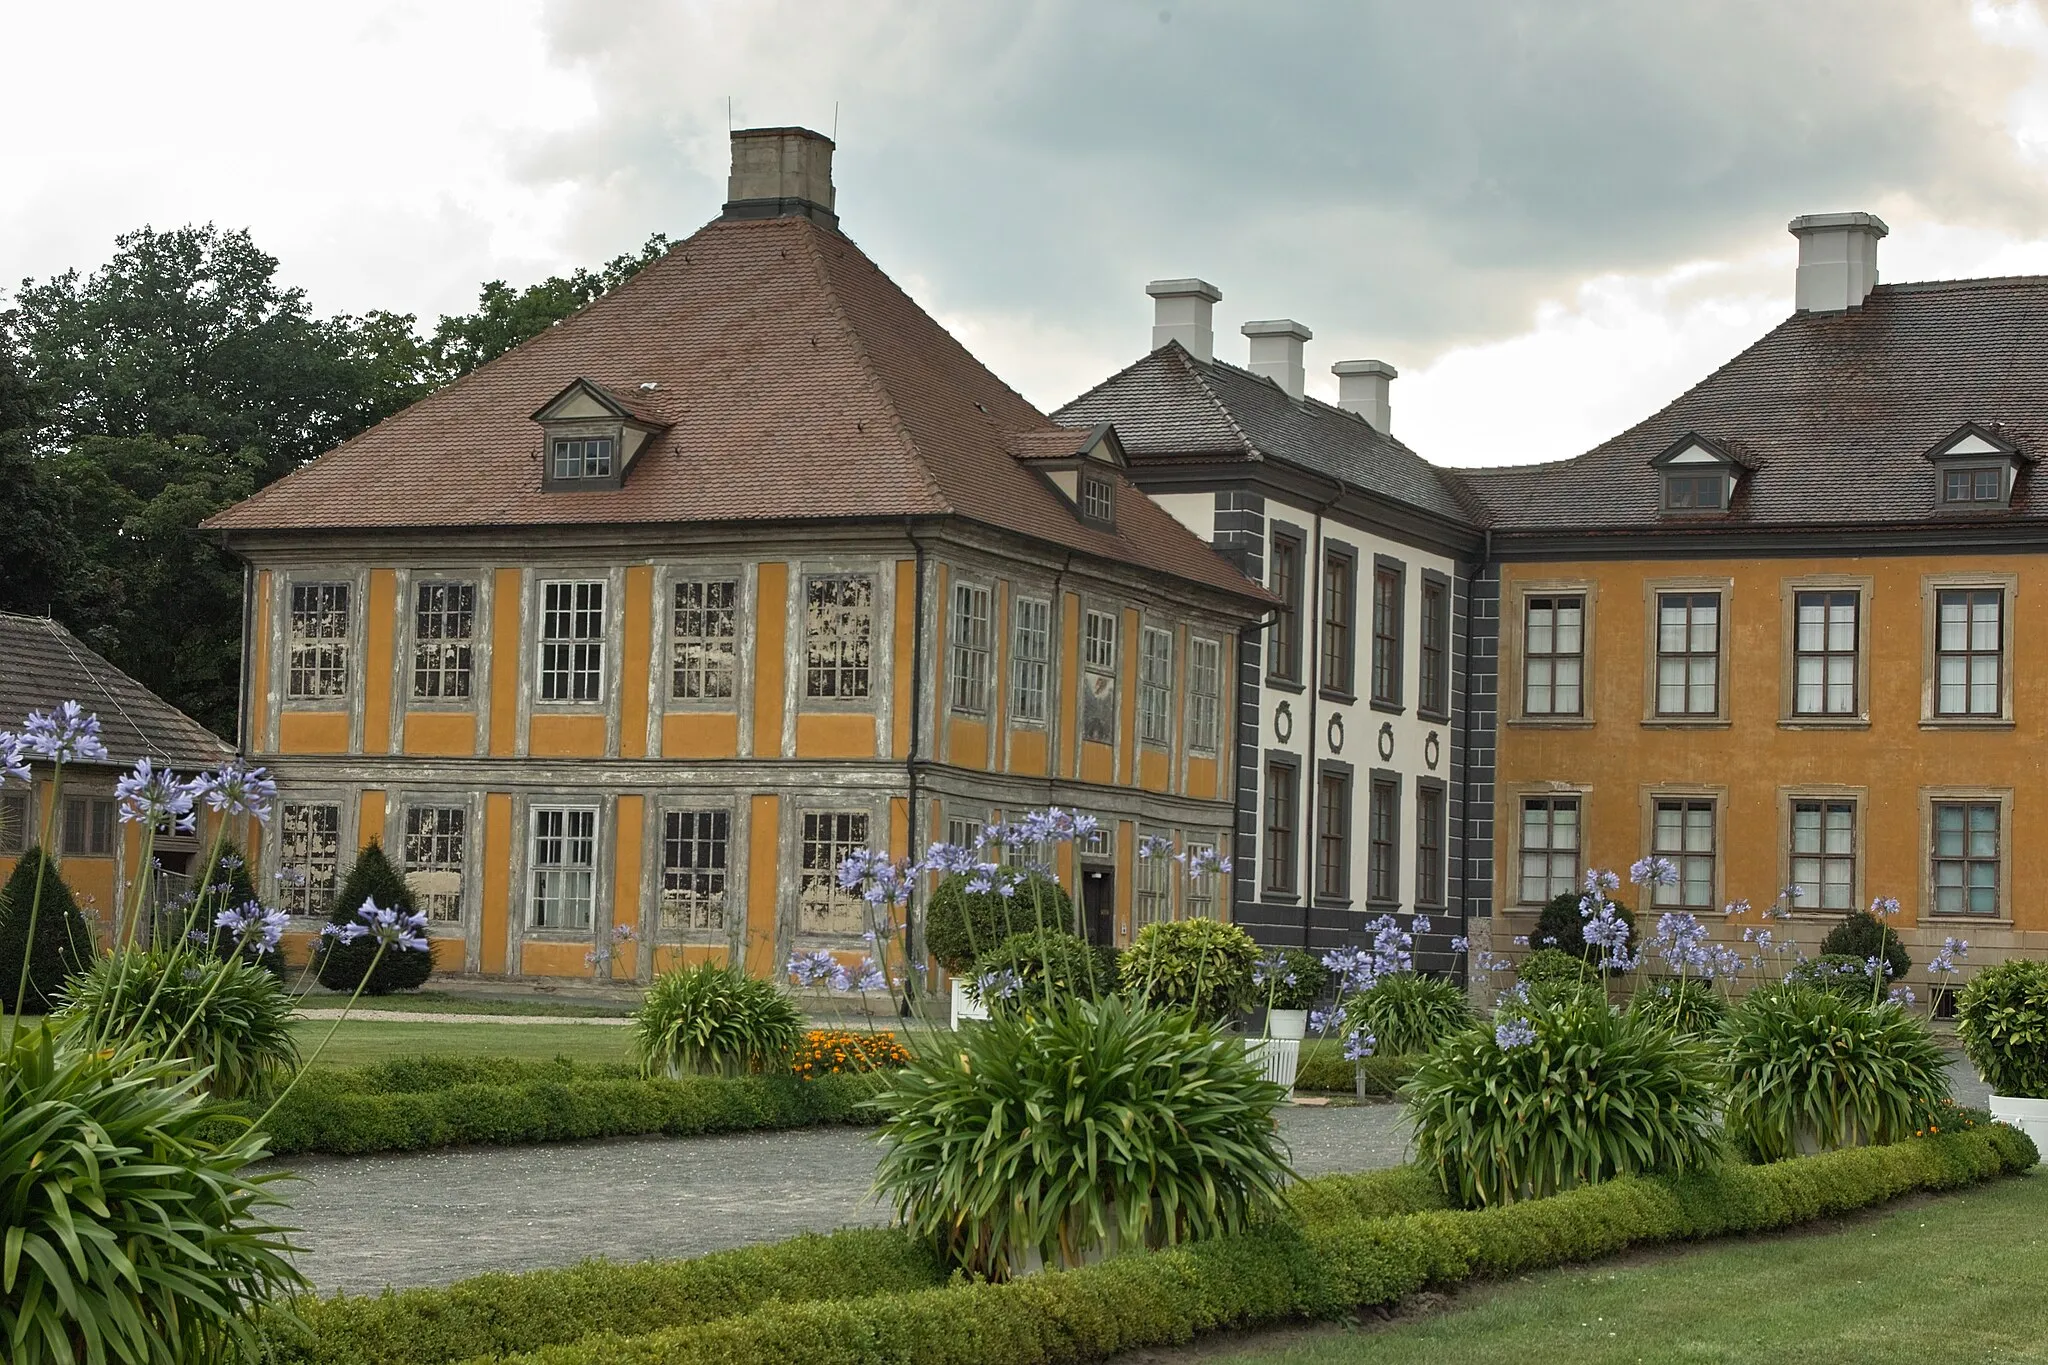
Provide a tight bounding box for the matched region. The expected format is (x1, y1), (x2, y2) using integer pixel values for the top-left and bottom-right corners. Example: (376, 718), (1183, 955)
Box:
(1401, 997), (1720, 1207)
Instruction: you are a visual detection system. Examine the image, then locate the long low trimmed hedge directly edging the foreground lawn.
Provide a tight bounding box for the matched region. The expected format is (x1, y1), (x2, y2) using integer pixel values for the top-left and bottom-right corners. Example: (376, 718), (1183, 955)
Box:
(471, 1128), (2038, 1365)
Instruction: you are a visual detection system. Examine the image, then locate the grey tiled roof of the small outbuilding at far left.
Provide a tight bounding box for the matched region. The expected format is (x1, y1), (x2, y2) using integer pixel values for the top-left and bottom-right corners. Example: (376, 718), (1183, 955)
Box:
(0, 612), (233, 772)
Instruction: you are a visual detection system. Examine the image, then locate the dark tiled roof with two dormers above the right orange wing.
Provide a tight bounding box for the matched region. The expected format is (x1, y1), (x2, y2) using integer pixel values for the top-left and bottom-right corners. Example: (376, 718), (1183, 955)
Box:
(1460, 276), (2048, 536)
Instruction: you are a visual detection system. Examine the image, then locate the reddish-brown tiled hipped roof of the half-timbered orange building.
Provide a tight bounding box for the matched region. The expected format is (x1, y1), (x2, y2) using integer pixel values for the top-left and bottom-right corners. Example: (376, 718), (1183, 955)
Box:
(207, 217), (1264, 600)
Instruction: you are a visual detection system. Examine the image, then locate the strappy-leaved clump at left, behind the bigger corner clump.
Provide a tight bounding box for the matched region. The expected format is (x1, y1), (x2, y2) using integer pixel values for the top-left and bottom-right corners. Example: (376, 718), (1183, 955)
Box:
(57, 945), (299, 1099)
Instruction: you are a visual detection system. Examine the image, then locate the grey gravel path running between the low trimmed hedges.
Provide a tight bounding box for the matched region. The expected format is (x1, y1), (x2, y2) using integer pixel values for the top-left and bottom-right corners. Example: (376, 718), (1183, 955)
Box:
(281, 1096), (1407, 1291)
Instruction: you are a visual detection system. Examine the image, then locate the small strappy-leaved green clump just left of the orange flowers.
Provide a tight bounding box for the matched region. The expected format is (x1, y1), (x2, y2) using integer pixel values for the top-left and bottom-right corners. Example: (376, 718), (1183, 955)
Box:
(633, 962), (803, 1076)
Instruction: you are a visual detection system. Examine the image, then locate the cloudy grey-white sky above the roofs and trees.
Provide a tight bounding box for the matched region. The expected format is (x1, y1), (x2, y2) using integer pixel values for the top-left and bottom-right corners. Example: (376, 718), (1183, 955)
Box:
(12, 0), (2048, 463)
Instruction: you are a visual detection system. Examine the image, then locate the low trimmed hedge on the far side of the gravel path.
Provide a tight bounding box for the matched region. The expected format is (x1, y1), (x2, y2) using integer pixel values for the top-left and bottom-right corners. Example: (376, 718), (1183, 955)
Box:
(203, 1056), (879, 1156)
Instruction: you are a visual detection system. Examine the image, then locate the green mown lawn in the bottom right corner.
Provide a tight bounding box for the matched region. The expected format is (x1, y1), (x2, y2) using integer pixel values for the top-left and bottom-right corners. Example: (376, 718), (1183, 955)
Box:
(1202, 1173), (2048, 1365)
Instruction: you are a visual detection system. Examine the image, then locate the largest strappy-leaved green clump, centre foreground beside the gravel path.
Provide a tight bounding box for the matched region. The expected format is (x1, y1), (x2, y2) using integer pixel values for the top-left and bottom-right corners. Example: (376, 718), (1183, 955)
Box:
(874, 994), (1290, 1279)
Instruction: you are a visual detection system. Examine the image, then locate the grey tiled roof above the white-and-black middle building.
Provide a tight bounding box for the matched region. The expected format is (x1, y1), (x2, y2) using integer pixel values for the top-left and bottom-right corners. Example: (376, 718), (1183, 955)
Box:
(1053, 342), (1473, 524)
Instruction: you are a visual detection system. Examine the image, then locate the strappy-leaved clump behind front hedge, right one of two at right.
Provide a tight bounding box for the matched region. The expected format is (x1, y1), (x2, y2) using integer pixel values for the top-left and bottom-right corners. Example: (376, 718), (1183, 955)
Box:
(1722, 984), (1948, 1160)
